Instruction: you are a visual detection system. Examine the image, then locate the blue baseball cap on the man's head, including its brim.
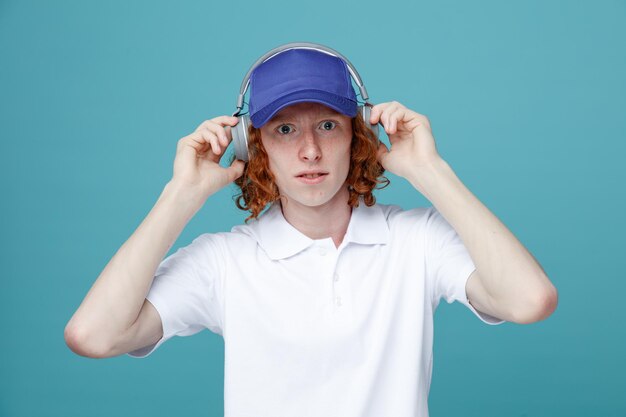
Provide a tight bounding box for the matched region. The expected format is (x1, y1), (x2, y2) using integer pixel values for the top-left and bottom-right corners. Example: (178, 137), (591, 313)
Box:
(248, 49), (358, 128)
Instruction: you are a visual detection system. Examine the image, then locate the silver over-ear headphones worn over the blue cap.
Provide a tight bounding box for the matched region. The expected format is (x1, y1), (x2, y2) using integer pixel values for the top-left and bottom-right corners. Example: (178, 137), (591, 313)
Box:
(231, 42), (378, 161)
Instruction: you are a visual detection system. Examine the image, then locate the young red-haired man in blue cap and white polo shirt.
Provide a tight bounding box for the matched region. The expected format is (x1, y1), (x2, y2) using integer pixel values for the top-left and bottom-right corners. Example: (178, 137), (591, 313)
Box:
(66, 49), (557, 417)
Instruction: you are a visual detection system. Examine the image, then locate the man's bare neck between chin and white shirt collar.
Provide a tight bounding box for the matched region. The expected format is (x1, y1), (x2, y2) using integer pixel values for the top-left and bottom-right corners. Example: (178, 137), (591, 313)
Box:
(281, 188), (352, 247)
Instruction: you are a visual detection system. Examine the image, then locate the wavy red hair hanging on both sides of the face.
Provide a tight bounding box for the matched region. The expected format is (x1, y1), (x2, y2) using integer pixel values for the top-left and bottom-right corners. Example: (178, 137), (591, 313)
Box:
(234, 110), (389, 222)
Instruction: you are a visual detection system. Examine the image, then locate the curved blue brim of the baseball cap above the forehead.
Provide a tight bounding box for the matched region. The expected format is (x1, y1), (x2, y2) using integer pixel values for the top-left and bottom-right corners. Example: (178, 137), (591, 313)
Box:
(250, 90), (358, 129)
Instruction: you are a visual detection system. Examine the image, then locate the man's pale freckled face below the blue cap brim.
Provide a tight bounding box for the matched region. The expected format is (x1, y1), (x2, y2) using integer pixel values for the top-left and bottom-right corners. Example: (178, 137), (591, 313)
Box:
(261, 103), (352, 209)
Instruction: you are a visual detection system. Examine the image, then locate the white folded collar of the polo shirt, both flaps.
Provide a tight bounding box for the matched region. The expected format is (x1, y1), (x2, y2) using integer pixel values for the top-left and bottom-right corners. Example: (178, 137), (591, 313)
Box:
(237, 200), (389, 260)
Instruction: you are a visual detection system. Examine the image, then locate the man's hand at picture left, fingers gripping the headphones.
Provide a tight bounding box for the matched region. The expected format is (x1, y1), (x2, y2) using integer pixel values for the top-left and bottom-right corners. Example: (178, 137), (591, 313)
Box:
(172, 116), (244, 204)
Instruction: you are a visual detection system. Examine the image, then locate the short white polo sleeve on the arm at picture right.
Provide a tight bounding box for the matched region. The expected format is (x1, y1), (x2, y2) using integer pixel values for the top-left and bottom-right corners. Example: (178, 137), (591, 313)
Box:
(425, 207), (504, 325)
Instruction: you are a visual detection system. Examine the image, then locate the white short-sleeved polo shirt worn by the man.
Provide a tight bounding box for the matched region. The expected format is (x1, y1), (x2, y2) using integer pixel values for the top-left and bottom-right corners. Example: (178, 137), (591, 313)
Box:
(128, 203), (503, 417)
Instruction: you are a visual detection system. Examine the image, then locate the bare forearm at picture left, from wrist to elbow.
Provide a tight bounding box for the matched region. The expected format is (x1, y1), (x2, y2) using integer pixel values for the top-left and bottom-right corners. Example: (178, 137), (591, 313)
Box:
(67, 182), (201, 349)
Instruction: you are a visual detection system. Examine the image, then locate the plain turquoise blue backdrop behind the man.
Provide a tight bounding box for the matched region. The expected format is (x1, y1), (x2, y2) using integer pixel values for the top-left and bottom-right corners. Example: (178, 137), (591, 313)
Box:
(0, 0), (626, 417)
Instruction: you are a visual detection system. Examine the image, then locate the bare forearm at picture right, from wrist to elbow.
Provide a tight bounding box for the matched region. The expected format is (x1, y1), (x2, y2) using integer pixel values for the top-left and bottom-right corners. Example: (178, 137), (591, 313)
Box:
(409, 159), (552, 311)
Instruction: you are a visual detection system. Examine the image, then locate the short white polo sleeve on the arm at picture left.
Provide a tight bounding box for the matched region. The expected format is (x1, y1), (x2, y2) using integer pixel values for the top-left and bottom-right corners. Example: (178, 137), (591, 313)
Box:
(127, 234), (223, 358)
